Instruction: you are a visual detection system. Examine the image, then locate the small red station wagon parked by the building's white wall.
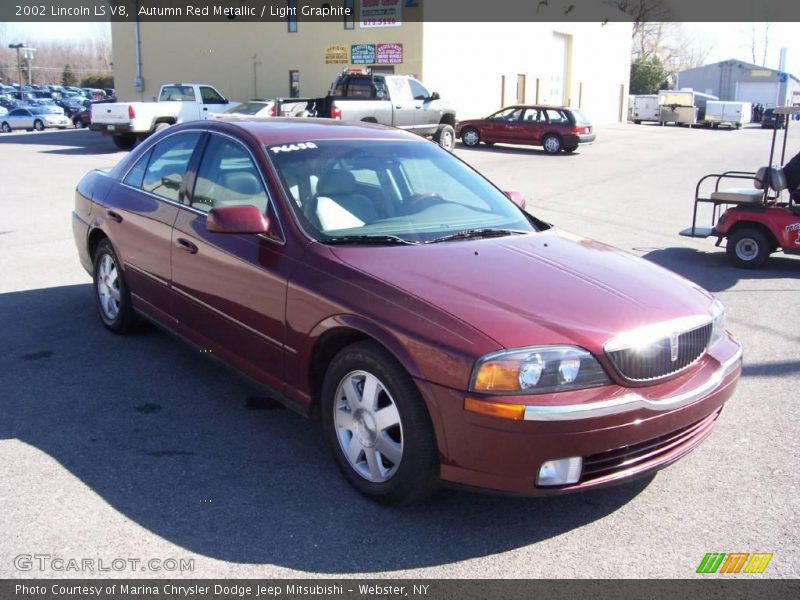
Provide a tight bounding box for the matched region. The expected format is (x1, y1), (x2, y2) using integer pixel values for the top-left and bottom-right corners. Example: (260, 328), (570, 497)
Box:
(456, 105), (595, 154)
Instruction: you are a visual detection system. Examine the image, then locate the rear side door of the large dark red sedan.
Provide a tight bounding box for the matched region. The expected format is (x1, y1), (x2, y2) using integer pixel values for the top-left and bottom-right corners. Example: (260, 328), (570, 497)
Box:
(111, 131), (203, 324)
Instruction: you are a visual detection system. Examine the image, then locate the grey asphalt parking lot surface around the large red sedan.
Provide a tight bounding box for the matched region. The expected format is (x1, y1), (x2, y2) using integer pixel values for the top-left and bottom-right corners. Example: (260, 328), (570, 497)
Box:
(0, 125), (800, 578)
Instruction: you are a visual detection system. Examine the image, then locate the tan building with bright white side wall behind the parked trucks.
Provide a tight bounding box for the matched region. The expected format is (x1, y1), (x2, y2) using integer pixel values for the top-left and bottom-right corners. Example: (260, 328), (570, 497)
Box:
(112, 7), (631, 123)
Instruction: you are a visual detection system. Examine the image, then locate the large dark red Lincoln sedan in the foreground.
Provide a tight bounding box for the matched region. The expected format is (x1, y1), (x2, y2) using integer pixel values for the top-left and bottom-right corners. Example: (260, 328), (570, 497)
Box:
(72, 119), (742, 504)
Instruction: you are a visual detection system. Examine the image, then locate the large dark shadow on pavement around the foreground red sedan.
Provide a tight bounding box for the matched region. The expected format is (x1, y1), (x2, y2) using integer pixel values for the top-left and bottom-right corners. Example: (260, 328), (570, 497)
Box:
(0, 284), (652, 574)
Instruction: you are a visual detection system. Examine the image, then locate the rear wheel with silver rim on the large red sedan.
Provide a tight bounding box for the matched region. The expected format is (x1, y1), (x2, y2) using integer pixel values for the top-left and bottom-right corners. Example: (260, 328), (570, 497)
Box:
(92, 239), (140, 334)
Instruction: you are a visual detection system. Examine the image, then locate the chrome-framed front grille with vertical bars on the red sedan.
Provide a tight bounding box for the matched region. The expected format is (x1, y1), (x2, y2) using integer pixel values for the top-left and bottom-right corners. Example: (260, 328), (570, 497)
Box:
(606, 323), (712, 381)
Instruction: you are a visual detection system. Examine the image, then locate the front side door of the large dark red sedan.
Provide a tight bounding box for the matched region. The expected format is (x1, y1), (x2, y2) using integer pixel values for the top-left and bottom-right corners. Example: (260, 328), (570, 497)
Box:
(172, 134), (287, 389)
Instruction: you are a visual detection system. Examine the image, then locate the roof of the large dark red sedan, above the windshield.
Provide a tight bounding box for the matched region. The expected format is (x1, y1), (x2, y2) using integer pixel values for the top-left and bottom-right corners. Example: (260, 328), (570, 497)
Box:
(209, 117), (422, 145)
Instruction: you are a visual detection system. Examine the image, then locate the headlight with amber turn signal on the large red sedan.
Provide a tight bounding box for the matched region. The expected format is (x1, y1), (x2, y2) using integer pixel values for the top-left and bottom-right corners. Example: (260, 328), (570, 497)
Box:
(470, 346), (611, 395)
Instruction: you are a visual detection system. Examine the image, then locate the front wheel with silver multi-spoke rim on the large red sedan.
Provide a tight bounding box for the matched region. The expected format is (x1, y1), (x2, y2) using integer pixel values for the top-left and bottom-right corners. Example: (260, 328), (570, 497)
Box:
(321, 341), (439, 506)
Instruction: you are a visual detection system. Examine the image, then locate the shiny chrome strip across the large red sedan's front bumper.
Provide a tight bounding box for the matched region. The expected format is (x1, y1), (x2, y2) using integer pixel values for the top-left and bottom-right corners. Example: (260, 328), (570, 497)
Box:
(524, 346), (742, 421)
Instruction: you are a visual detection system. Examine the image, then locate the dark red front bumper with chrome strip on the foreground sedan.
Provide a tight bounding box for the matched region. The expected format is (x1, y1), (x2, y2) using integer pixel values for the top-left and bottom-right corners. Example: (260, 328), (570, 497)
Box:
(421, 339), (742, 496)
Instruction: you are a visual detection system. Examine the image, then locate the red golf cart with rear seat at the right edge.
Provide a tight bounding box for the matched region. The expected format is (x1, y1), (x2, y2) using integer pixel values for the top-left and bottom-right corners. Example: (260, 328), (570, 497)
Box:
(680, 106), (800, 269)
